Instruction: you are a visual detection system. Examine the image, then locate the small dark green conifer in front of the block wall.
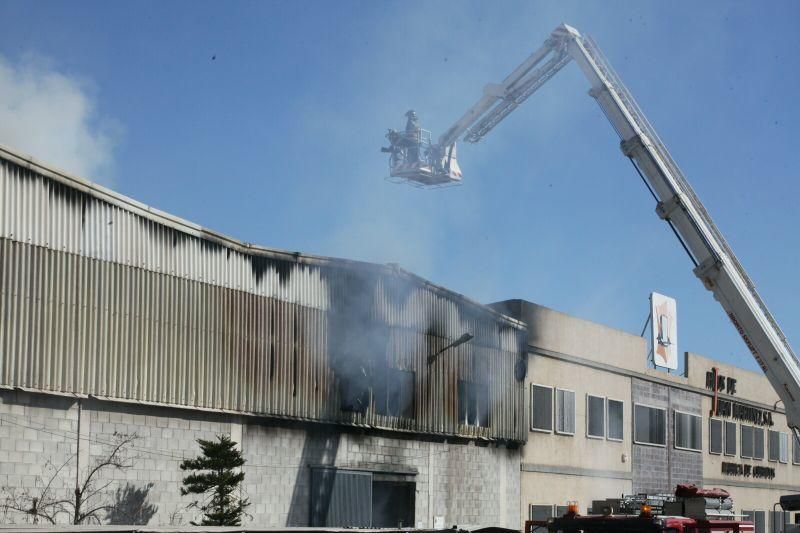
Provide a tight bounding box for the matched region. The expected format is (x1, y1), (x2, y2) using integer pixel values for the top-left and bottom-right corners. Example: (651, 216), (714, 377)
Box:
(181, 435), (250, 526)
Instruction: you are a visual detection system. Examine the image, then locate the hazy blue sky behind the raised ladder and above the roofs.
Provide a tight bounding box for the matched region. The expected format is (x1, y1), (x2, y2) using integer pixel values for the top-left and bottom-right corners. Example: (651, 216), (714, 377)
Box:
(0, 0), (800, 369)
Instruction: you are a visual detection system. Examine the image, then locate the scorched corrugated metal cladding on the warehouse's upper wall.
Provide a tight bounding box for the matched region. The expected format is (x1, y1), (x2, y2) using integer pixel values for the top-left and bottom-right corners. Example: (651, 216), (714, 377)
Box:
(0, 151), (527, 441)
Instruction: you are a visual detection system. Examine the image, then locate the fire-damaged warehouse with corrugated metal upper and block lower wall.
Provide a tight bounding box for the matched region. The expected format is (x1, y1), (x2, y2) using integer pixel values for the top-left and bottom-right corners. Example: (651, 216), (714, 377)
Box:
(0, 143), (527, 527)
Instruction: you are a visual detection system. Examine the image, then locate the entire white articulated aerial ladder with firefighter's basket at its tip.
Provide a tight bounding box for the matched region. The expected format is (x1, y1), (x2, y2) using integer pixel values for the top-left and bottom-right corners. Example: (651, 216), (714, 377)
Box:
(383, 24), (800, 436)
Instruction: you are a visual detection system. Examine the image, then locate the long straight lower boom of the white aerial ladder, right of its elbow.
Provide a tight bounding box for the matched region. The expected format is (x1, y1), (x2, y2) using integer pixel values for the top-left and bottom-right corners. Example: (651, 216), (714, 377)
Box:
(561, 26), (800, 429)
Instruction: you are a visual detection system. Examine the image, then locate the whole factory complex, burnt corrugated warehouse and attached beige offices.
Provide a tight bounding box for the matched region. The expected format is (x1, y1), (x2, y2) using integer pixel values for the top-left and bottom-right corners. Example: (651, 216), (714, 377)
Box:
(0, 141), (800, 533)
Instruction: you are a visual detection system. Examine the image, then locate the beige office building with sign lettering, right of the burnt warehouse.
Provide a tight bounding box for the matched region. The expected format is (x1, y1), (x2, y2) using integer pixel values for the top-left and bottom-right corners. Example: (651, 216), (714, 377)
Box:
(495, 300), (800, 533)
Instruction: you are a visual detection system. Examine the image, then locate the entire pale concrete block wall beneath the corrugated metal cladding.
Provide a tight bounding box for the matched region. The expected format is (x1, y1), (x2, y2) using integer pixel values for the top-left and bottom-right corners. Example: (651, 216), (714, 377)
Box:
(0, 391), (520, 527)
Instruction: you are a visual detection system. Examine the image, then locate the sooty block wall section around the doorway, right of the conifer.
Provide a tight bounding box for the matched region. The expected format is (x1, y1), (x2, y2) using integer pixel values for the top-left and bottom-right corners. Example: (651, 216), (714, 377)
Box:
(243, 424), (520, 527)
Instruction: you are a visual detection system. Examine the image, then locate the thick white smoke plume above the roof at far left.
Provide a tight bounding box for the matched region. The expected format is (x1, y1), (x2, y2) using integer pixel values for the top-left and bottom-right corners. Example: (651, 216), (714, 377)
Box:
(0, 55), (120, 184)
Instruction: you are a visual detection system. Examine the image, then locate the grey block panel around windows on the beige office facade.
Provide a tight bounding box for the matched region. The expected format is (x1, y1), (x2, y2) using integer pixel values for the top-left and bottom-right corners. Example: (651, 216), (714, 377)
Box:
(631, 378), (703, 493)
